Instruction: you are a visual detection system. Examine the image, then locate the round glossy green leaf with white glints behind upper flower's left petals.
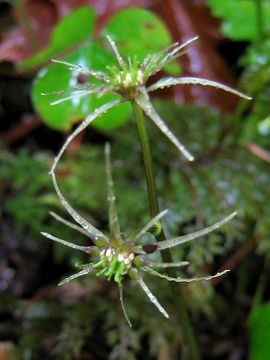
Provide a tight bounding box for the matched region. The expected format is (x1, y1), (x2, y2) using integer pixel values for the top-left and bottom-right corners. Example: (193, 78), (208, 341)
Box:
(32, 42), (131, 130)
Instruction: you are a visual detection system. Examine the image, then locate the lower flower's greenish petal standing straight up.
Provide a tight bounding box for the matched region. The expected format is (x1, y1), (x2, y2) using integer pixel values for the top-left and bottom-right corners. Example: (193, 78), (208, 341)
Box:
(105, 143), (120, 240)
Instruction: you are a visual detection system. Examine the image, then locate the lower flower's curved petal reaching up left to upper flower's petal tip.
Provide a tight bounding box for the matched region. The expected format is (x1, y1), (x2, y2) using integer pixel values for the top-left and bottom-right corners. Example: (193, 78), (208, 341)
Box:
(51, 173), (108, 242)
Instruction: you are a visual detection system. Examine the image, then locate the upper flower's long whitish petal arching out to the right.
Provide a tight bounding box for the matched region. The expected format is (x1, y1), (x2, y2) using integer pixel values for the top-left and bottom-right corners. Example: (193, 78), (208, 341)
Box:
(147, 76), (252, 100)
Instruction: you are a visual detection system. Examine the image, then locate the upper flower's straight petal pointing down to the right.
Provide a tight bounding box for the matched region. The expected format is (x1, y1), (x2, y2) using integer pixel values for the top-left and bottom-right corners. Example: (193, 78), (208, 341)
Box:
(135, 91), (194, 161)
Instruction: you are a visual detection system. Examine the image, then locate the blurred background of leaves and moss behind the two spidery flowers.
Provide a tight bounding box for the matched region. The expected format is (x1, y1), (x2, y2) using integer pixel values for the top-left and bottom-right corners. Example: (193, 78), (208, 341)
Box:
(0, 0), (270, 360)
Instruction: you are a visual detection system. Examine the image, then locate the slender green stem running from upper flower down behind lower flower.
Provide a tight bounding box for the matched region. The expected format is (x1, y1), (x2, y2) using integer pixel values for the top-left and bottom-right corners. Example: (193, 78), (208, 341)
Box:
(132, 101), (201, 360)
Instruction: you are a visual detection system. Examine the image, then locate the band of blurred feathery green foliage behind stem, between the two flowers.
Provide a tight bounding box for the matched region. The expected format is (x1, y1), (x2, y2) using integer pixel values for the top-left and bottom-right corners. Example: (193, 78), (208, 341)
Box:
(1, 101), (270, 266)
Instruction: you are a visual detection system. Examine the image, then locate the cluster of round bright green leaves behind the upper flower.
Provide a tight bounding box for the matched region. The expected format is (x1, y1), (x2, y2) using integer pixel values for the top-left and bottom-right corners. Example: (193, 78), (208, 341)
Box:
(31, 7), (175, 130)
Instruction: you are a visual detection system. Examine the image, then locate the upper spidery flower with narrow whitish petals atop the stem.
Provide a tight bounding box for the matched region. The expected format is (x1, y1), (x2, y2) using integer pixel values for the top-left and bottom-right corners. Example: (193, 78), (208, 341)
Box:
(47, 36), (251, 172)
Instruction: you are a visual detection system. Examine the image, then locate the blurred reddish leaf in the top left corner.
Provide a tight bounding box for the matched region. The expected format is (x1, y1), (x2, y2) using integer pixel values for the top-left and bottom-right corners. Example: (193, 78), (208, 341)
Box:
(0, 0), (154, 62)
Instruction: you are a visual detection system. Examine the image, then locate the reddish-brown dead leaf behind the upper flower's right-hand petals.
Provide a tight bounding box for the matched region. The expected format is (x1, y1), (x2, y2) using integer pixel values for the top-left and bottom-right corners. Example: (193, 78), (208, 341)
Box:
(158, 0), (238, 112)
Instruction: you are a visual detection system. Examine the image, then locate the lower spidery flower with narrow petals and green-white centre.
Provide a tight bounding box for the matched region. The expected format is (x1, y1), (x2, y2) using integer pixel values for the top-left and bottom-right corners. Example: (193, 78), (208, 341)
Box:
(42, 144), (236, 326)
